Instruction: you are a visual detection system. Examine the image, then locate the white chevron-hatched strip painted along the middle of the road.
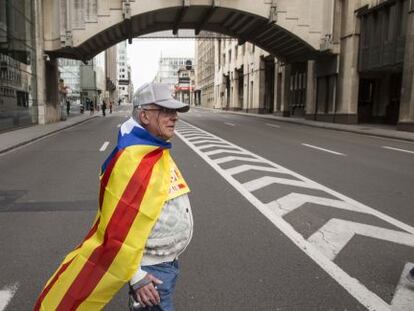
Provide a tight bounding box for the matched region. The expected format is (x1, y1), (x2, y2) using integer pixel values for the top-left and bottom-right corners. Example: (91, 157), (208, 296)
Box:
(176, 121), (414, 310)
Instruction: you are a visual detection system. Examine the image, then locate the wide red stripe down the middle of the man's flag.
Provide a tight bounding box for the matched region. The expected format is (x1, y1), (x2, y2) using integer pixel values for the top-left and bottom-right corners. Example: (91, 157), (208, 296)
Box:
(56, 149), (162, 311)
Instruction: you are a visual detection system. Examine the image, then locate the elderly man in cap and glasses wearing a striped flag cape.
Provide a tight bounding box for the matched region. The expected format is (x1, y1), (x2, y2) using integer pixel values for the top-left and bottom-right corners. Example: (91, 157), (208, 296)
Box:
(34, 83), (193, 311)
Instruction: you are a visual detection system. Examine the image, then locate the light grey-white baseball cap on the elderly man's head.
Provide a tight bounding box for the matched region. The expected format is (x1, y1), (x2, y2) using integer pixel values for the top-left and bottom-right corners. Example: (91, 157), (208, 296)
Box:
(132, 82), (190, 112)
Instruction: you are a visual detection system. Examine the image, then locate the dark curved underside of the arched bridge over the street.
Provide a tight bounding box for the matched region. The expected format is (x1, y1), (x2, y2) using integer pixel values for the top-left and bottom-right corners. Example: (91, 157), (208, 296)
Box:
(50, 6), (318, 62)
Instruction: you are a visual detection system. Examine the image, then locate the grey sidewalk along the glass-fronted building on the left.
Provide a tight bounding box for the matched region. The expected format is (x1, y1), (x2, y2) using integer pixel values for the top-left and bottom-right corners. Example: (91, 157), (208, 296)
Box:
(0, 112), (100, 154)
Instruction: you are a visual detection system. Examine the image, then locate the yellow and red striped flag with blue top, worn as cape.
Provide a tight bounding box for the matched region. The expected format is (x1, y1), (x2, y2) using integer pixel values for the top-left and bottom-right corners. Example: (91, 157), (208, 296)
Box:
(34, 118), (190, 311)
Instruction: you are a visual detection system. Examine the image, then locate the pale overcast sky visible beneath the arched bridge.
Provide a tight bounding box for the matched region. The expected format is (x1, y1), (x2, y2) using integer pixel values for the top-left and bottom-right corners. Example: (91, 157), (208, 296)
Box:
(127, 39), (195, 90)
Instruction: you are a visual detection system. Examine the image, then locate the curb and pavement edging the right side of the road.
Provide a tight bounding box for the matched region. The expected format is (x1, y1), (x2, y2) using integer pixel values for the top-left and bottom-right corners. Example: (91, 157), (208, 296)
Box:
(192, 107), (414, 142)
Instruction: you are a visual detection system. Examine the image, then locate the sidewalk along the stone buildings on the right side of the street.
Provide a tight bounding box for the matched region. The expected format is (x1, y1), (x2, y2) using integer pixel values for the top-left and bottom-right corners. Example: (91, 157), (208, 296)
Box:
(191, 107), (414, 142)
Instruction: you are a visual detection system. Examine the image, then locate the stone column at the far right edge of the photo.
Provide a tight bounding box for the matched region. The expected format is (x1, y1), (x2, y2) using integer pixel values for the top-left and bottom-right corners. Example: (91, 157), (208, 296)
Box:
(397, 5), (414, 132)
